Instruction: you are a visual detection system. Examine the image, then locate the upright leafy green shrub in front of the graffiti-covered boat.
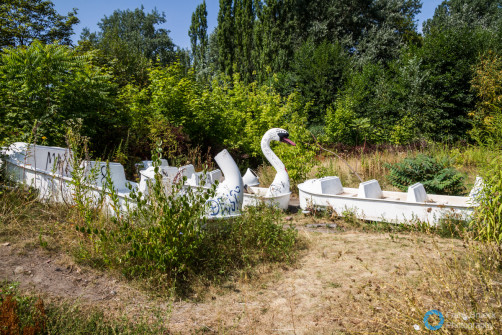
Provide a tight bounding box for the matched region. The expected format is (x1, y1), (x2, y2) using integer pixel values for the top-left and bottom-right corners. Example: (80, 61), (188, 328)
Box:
(77, 148), (214, 280)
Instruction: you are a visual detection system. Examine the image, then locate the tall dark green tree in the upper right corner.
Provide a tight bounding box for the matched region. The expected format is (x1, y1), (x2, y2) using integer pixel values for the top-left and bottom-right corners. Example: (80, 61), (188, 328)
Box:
(418, 0), (502, 139)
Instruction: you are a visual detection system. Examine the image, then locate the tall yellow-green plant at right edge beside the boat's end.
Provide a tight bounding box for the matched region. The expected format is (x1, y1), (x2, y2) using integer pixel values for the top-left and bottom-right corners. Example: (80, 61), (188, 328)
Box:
(471, 153), (502, 244)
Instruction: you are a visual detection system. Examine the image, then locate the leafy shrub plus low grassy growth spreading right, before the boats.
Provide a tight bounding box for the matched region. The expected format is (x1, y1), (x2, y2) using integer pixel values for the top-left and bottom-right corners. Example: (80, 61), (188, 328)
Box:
(77, 147), (297, 290)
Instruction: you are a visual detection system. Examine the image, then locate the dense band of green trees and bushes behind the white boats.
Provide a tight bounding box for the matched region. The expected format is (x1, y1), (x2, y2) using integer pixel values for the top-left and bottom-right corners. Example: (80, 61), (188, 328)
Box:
(0, 0), (502, 171)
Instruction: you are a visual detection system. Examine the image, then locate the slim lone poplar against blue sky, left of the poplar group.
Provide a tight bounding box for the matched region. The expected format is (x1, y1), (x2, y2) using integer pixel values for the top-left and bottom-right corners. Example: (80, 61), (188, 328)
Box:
(188, 0), (209, 71)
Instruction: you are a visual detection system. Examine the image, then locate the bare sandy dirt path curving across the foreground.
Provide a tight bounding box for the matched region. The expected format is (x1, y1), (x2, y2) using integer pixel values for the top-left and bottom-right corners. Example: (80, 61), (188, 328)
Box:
(0, 224), (461, 334)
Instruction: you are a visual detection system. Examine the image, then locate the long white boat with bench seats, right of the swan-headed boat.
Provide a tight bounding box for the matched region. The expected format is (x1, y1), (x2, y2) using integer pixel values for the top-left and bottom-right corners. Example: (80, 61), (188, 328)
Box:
(298, 176), (482, 225)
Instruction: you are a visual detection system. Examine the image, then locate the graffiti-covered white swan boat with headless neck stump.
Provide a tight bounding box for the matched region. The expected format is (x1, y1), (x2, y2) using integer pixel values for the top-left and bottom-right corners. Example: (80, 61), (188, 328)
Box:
(0, 142), (244, 218)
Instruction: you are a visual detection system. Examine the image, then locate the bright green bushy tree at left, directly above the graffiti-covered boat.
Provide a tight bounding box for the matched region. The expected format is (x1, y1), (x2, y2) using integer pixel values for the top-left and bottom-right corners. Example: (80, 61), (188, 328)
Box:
(0, 41), (121, 150)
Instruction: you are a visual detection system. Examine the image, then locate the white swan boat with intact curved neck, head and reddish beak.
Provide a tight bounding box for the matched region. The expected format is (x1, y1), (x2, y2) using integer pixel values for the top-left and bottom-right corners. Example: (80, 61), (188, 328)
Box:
(242, 128), (296, 209)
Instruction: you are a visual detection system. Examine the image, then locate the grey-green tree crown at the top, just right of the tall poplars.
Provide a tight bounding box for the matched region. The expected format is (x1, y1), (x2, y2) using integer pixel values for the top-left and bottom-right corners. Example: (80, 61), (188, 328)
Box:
(306, 0), (422, 63)
